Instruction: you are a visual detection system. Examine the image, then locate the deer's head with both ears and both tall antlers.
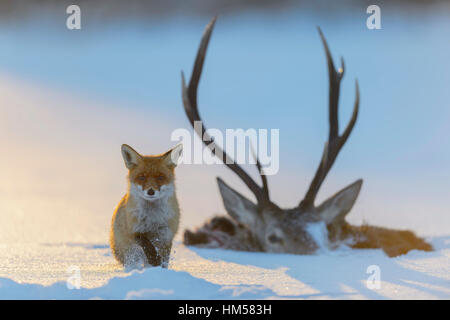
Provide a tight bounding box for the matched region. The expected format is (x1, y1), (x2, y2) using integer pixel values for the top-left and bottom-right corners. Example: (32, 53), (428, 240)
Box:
(182, 17), (362, 254)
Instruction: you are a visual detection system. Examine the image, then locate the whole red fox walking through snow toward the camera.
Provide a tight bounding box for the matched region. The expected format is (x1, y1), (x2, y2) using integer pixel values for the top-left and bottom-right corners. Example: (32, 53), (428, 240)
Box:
(110, 144), (182, 268)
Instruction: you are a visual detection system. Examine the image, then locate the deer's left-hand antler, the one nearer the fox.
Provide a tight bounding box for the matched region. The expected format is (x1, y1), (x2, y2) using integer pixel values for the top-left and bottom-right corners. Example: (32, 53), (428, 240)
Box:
(181, 17), (270, 205)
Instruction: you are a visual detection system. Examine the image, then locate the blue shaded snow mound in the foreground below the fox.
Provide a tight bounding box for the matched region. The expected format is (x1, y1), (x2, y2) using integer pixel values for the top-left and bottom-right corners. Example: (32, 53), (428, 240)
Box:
(0, 268), (273, 299)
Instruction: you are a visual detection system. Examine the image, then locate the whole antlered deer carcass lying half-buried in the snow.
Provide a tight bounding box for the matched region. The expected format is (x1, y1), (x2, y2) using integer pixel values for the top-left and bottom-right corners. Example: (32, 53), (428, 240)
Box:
(182, 18), (432, 256)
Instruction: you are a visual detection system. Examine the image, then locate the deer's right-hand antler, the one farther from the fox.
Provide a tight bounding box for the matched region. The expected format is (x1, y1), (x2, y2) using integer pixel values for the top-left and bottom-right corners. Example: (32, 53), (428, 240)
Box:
(299, 28), (359, 209)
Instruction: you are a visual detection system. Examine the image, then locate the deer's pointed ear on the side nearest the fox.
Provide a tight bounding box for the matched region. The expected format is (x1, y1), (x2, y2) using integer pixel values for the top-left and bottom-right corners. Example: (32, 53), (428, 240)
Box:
(217, 178), (258, 227)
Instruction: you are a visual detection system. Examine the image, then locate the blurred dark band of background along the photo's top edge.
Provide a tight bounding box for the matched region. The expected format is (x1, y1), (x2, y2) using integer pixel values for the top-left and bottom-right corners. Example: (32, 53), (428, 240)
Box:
(0, 0), (448, 19)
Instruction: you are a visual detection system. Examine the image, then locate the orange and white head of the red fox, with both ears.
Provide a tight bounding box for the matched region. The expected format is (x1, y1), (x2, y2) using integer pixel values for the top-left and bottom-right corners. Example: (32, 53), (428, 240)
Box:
(122, 144), (183, 201)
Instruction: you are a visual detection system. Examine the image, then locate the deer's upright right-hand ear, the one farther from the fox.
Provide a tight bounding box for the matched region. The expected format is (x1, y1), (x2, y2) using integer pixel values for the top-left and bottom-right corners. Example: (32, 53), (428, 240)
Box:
(317, 179), (363, 224)
